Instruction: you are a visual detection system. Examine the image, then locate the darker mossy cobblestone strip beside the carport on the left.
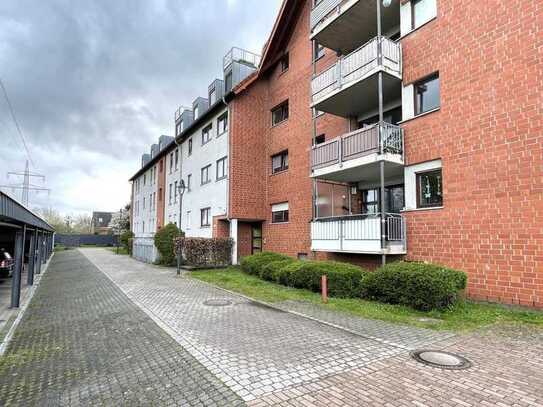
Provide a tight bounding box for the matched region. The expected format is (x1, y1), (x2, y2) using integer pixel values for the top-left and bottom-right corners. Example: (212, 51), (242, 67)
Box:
(0, 250), (244, 406)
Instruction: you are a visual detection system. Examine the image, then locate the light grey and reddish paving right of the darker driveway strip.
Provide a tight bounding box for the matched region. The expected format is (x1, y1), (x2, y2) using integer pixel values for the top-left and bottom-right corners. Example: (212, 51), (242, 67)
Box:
(79, 250), (543, 406)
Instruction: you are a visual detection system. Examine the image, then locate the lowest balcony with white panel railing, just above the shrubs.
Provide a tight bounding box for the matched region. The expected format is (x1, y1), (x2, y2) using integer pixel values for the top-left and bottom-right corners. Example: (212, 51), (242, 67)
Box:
(311, 214), (407, 254)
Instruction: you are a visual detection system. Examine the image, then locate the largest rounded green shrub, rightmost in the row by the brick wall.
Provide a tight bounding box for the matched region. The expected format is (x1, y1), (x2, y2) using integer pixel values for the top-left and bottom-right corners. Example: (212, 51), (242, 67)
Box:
(361, 262), (467, 311)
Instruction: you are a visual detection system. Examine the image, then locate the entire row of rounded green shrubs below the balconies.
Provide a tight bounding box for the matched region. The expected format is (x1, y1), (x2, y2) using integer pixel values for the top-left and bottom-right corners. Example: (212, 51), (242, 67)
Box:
(241, 252), (467, 311)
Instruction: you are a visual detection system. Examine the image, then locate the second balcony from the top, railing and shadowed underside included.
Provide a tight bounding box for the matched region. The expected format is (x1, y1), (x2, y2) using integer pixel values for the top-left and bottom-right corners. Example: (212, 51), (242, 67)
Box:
(311, 37), (402, 117)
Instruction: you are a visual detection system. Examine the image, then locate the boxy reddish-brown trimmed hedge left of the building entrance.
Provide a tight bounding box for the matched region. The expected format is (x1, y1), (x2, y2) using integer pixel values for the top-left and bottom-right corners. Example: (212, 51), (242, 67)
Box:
(175, 237), (234, 267)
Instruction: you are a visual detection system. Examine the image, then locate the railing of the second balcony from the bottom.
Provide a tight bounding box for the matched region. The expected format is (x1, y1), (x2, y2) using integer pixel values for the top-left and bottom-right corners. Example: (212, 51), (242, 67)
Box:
(311, 122), (403, 170)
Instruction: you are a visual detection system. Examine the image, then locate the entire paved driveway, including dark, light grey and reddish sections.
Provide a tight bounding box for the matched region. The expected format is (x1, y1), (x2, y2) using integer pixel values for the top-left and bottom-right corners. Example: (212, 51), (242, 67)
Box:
(0, 249), (543, 406)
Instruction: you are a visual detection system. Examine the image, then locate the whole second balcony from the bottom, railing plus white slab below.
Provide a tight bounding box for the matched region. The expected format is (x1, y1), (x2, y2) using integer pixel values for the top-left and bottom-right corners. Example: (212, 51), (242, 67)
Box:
(311, 122), (404, 182)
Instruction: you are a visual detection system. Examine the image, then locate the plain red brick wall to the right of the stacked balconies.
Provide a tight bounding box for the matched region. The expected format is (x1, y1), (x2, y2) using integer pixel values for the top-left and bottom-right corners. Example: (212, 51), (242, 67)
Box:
(402, 0), (543, 306)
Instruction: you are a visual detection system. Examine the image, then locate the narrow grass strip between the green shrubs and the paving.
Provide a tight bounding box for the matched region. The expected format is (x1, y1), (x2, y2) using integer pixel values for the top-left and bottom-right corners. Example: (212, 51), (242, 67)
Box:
(191, 267), (543, 332)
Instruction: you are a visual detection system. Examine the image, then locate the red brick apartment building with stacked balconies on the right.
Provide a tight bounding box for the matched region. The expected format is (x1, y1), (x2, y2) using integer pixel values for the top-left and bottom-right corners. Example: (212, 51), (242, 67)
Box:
(228, 0), (543, 307)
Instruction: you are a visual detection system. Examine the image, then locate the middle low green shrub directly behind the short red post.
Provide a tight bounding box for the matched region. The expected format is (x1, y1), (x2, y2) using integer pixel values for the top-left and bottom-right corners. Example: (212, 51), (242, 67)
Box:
(279, 261), (368, 298)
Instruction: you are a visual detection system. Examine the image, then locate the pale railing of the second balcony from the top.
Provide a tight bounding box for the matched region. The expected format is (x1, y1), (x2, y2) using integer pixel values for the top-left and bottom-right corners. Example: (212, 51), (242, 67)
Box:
(311, 37), (402, 103)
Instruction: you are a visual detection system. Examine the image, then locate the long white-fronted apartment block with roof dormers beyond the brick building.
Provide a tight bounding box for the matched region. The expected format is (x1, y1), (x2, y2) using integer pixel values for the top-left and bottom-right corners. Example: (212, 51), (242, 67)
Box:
(130, 48), (260, 262)
